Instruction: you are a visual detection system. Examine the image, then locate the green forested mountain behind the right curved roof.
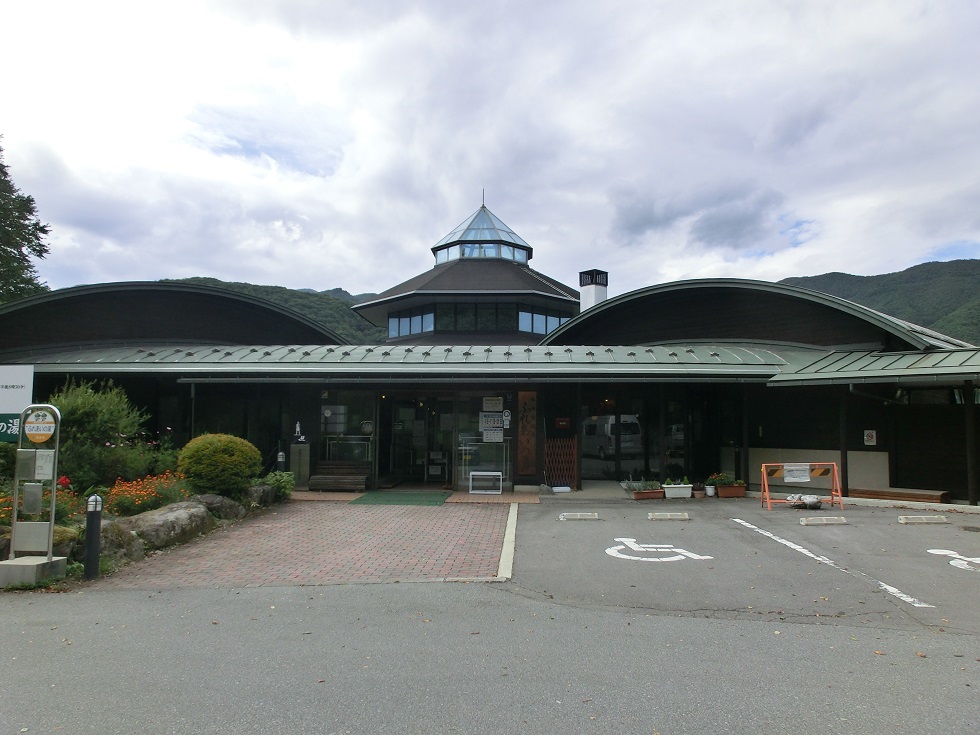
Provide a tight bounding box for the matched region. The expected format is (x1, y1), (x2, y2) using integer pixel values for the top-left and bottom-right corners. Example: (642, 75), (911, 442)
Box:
(780, 260), (980, 345)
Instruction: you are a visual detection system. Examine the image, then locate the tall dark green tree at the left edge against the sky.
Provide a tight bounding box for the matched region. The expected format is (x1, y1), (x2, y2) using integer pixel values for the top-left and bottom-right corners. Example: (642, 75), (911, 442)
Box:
(0, 141), (50, 303)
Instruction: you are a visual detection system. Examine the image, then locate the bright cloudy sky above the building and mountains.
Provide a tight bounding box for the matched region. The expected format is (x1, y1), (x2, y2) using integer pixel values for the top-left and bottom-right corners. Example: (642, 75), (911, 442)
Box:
(0, 0), (980, 295)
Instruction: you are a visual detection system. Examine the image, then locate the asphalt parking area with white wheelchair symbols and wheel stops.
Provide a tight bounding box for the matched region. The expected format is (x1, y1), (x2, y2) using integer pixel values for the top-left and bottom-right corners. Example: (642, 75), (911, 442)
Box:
(513, 498), (980, 634)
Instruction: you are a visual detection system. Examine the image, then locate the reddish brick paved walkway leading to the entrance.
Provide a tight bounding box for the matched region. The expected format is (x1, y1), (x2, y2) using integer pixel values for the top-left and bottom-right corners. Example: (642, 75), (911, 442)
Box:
(92, 501), (510, 589)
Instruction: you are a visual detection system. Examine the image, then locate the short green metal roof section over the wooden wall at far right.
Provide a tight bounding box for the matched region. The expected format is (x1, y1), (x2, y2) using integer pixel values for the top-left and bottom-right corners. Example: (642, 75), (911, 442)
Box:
(769, 348), (980, 386)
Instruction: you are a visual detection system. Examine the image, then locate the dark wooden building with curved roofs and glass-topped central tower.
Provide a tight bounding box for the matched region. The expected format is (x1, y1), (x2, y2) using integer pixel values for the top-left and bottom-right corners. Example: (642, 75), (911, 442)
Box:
(0, 206), (980, 502)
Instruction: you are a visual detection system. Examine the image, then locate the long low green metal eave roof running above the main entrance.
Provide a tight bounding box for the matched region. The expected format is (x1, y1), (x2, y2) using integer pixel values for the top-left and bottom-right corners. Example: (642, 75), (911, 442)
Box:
(7, 344), (812, 382)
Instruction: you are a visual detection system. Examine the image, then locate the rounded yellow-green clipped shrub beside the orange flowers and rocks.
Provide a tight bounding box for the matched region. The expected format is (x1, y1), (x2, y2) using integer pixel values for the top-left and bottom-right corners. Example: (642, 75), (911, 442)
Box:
(177, 434), (262, 498)
